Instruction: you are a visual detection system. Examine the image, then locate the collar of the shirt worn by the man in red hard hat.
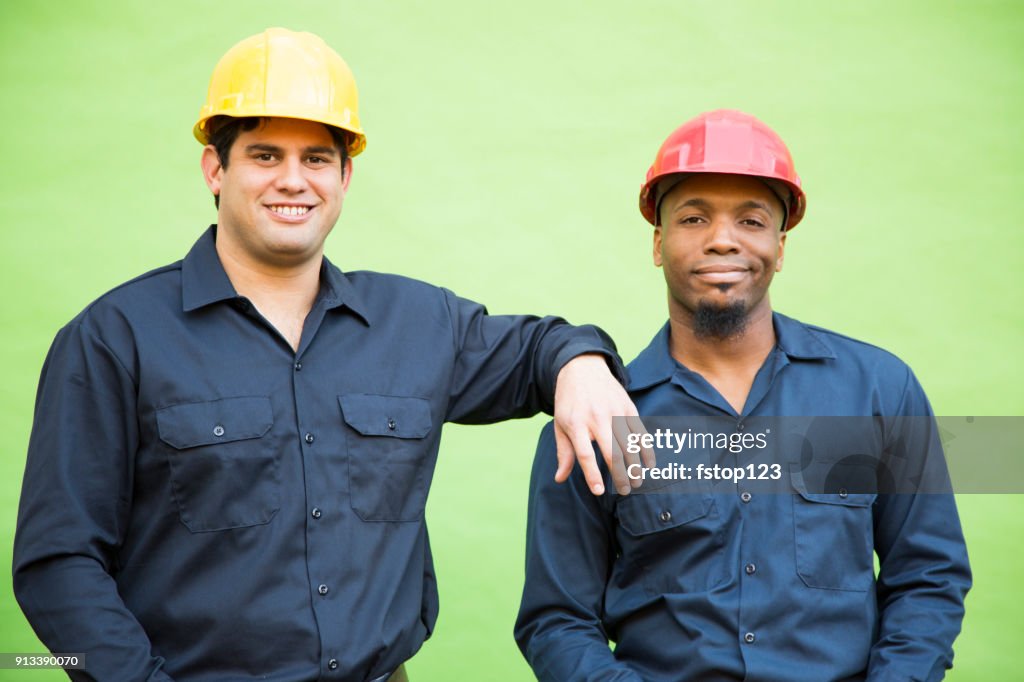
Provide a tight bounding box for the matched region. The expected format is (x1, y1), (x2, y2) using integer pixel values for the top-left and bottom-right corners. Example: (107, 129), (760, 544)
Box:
(627, 312), (836, 391)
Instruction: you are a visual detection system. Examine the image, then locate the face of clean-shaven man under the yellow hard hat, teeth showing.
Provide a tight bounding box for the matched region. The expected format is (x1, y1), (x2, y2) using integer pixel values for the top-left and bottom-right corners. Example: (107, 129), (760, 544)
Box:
(203, 118), (351, 267)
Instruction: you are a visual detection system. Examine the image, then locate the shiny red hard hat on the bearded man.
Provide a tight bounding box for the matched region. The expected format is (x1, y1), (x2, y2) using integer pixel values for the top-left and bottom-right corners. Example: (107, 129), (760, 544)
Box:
(640, 109), (807, 230)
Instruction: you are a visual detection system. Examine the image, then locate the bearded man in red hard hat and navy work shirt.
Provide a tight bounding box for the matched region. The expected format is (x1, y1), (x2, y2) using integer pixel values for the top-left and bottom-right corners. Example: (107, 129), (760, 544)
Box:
(515, 111), (971, 682)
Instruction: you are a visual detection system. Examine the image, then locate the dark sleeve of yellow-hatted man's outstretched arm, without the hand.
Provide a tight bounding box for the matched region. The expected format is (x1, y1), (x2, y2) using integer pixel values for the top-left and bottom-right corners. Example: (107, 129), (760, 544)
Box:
(443, 290), (626, 424)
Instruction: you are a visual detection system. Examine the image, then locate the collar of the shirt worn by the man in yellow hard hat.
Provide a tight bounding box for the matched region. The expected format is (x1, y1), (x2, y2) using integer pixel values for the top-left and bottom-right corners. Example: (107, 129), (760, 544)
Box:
(181, 225), (370, 325)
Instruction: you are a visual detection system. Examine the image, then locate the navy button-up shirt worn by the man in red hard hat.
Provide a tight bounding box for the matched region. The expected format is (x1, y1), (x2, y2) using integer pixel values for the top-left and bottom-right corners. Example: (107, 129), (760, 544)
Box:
(516, 314), (971, 682)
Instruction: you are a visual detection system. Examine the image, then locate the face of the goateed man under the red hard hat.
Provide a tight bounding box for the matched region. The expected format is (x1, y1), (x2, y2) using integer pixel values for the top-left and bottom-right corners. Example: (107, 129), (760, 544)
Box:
(654, 173), (785, 326)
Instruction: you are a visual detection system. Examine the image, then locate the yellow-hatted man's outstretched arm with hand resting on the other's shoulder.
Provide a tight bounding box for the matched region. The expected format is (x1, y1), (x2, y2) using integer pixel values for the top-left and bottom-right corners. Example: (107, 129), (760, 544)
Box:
(444, 290), (653, 495)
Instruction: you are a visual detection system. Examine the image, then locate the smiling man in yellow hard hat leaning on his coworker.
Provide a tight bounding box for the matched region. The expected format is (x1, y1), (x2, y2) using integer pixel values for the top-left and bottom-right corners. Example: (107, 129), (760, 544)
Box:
(13, 29), (636, 682)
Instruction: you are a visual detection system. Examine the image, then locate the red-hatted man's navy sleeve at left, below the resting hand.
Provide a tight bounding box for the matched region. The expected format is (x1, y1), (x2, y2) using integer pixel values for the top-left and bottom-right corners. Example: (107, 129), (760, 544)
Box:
(515, 423), (642, 682)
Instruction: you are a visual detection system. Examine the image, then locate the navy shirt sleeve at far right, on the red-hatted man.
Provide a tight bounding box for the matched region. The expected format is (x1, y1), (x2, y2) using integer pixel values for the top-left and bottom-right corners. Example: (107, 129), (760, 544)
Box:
(867, 369), (971, 682)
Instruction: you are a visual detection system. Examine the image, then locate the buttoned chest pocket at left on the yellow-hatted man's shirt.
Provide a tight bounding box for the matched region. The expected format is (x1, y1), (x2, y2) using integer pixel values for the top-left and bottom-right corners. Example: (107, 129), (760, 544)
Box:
(157, 395), (281, 532)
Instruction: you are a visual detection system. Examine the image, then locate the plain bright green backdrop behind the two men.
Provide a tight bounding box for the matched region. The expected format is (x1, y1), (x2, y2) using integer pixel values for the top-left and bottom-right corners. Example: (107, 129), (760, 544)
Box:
(0, 0), (1024, 682)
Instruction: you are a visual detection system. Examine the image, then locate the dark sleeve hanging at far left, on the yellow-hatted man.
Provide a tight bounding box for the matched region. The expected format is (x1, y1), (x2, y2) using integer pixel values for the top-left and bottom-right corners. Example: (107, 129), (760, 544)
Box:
(13, 319), (171, 681)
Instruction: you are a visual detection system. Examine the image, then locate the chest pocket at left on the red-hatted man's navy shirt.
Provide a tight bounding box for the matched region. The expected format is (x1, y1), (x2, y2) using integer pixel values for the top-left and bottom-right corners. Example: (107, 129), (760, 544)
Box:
(615, 493), (728, 595)
